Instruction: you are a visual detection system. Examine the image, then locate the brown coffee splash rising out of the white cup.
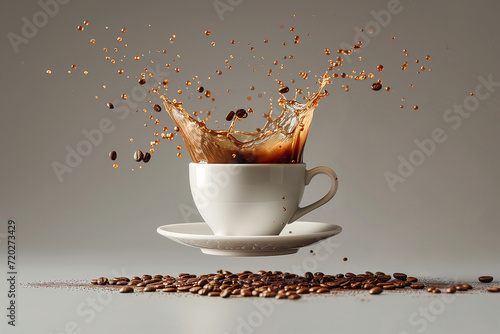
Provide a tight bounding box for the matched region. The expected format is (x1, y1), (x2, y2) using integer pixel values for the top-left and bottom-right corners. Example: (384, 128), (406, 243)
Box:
(161, 73), (330, 163)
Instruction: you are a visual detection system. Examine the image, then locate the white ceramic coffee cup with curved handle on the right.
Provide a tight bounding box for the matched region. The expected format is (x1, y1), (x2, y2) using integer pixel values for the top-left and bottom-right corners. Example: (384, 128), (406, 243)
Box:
(189, 163), (338, 236)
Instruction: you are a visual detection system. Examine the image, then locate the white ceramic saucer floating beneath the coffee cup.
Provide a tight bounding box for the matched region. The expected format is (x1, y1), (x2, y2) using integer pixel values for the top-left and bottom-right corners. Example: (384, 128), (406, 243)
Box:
(156, 221), (342, 256)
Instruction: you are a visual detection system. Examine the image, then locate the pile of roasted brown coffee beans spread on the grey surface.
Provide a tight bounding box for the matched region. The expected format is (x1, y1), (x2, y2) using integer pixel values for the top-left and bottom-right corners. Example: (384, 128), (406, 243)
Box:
(91, 270), (500, 299)
